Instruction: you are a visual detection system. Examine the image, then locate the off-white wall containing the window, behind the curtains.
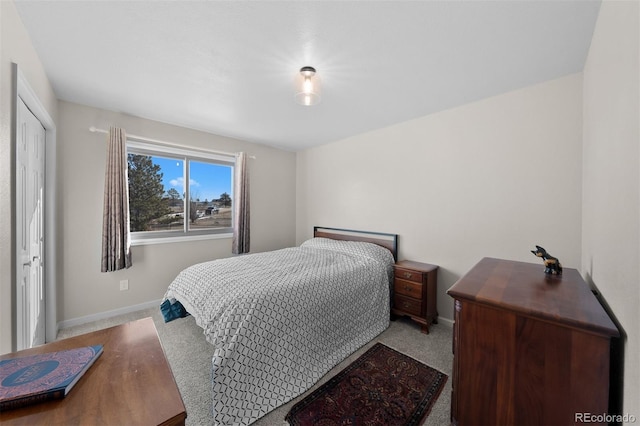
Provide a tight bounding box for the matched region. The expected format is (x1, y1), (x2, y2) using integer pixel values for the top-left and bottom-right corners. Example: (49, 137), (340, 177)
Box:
(58, 101), (295, 322)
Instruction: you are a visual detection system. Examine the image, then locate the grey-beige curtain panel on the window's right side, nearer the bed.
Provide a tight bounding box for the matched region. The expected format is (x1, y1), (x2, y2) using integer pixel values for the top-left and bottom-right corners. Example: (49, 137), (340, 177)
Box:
(231, 152), (250, 254)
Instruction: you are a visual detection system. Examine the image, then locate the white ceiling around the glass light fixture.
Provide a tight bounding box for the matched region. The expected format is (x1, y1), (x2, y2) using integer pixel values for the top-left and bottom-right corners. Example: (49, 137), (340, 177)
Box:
(15, 0), (600, 151)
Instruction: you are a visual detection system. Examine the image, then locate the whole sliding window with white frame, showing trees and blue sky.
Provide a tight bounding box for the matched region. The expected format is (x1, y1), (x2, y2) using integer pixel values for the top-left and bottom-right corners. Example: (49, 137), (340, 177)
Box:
(127, 140), (235, 244)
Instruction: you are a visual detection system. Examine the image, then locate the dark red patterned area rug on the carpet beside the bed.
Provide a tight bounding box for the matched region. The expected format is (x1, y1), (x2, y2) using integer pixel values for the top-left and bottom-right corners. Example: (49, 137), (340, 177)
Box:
(285, 343), (447, 426)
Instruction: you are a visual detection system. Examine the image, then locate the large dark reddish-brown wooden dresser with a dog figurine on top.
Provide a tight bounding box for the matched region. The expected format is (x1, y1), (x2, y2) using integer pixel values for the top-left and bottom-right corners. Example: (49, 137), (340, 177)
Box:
(447, 258), (619, 425)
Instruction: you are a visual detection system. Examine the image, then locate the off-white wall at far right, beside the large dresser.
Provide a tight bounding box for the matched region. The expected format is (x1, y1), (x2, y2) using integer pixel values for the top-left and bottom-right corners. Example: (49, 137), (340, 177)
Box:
(582, 1), (640, 418)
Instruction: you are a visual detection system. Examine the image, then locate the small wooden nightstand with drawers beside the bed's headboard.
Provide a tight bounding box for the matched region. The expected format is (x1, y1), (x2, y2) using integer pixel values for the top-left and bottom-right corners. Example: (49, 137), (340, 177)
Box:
(391, 260), (438, 334)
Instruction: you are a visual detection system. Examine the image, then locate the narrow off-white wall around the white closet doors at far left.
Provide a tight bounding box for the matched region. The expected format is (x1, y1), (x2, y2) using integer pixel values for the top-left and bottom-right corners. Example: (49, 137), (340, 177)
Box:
(0, 1), (58, 354)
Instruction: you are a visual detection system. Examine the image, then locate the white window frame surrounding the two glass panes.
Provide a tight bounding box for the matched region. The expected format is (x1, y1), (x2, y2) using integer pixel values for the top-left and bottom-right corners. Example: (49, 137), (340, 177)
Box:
(126, 140), (236, 246)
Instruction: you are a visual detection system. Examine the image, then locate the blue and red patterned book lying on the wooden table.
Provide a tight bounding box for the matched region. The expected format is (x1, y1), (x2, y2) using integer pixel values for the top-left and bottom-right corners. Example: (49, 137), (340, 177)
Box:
(0, 345), (102, 411)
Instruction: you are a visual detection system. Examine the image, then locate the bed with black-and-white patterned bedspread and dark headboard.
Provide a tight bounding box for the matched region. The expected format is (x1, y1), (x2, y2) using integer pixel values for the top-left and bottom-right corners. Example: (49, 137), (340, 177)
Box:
(164, 227), (397, 425)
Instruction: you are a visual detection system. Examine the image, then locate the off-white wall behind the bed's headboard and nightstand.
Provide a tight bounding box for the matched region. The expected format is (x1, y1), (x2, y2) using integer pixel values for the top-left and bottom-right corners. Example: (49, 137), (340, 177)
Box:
(296, 74), (582, 319)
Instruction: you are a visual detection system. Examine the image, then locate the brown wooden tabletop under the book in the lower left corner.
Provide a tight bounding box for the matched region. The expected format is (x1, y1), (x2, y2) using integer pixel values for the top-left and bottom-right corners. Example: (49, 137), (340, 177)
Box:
(0, 318), (187, 426)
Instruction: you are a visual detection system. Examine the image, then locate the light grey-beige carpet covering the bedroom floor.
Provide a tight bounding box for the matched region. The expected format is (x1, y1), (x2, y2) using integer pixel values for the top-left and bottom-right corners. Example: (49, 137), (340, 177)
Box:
(58, 307), (453, 426)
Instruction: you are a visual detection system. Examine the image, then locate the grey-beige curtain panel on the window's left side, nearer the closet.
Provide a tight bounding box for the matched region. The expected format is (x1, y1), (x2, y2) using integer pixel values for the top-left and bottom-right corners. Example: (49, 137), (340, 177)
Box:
(102, 127), (131, 272)
